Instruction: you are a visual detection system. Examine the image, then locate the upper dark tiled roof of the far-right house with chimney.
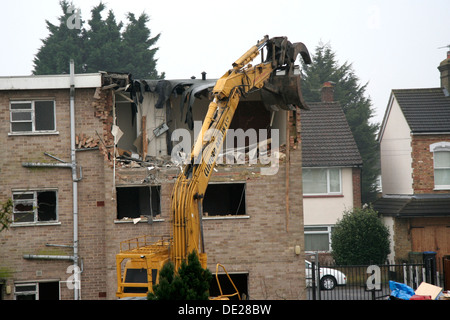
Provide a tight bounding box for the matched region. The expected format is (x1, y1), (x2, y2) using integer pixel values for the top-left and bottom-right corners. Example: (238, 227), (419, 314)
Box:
(392, 88), (450, 133)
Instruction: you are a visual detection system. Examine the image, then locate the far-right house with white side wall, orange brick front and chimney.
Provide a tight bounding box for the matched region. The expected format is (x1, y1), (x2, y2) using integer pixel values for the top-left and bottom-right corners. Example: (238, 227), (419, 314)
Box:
(375, 52), (450, 268)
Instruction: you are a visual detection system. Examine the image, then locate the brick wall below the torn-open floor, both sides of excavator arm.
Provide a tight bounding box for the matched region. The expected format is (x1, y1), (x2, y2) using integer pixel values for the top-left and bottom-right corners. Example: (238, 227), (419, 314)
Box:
(106, 109), (306, 299)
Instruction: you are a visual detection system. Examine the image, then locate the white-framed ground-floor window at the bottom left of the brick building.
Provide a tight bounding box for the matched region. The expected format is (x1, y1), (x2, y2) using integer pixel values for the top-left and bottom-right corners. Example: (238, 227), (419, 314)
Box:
(14, 281), (59, 300)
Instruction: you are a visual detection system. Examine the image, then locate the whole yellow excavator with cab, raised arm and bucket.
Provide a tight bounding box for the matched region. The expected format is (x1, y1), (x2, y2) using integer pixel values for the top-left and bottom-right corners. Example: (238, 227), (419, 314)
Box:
(116, 36), (311, 298)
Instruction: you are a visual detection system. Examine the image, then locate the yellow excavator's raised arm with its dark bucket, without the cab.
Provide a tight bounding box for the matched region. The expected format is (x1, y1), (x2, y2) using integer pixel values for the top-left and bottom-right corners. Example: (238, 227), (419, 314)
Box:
(171, 36), (311, 270)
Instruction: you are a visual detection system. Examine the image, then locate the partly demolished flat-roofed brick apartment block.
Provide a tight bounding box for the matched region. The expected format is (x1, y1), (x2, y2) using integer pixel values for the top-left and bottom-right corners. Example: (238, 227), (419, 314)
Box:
(0, 67), (306, 300)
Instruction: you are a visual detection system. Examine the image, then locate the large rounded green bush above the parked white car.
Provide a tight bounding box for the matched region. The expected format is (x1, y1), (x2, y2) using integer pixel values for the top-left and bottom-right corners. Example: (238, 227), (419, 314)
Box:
(331, 207), (390, 265)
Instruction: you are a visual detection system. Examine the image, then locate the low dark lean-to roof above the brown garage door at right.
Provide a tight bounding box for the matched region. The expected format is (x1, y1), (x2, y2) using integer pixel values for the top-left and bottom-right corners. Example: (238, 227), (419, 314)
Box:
(374, 194), (450, 218)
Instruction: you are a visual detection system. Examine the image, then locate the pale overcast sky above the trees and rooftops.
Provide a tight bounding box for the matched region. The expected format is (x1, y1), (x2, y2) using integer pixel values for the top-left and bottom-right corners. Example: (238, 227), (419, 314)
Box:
(0, 0), (450, 122)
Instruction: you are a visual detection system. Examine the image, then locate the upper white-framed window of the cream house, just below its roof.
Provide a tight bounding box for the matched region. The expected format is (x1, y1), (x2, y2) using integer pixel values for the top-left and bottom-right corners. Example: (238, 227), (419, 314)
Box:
(302, 168), (341, 195)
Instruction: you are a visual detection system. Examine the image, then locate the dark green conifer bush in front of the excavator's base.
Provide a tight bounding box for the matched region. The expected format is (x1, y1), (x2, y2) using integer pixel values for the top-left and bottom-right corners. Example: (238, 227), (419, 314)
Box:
(148, 252), (212, 300)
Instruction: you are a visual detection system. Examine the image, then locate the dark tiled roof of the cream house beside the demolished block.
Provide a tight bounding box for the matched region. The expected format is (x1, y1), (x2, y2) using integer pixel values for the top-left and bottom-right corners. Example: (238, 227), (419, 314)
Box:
(300, 102), (362, 167)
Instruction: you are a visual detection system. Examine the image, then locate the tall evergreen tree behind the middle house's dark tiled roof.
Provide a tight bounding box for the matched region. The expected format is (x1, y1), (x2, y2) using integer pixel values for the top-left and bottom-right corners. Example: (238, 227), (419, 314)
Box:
(302, 44), (379, 203)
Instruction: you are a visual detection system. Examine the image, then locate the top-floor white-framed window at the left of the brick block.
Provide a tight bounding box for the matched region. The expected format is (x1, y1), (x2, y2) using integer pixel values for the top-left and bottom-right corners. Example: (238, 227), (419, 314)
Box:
(10, 100), (56, 133)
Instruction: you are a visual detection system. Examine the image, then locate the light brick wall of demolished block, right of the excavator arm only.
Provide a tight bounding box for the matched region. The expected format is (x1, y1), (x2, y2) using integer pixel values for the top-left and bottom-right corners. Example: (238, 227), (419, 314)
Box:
(204, 160), (305, 299)
